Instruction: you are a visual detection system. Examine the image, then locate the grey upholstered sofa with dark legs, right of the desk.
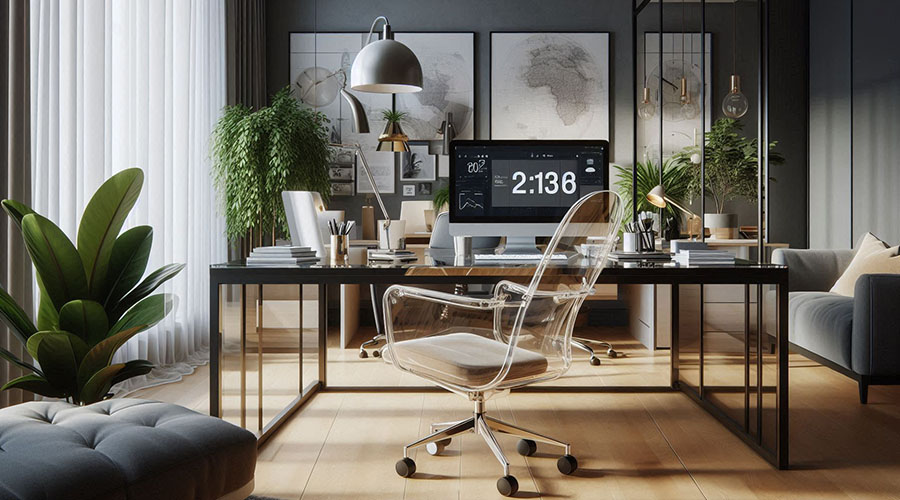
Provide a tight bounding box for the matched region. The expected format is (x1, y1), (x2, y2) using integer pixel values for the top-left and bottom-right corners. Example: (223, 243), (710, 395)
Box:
(772, 249), (900, 403)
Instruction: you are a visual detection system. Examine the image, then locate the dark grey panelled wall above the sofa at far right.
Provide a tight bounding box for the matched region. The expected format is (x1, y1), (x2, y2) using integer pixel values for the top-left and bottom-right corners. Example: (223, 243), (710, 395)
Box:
(809, 0), (900, 248)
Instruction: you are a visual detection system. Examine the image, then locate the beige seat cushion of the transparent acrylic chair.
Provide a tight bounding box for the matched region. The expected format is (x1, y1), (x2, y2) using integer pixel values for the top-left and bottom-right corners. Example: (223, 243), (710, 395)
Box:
(394, 332), (547, 387)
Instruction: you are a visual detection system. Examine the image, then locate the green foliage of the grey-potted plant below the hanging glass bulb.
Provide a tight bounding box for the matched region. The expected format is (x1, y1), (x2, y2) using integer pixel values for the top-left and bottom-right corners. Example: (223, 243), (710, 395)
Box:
(673, 118), (784, 213)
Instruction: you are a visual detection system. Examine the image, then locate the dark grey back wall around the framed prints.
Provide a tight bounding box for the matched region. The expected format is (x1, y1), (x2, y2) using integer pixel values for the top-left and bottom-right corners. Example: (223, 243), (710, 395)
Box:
(266, 0), (808, 246)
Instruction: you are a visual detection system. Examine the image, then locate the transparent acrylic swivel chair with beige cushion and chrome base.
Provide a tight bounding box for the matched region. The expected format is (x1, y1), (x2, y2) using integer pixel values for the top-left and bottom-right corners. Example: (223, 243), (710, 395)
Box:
(384, 191), (622, 496)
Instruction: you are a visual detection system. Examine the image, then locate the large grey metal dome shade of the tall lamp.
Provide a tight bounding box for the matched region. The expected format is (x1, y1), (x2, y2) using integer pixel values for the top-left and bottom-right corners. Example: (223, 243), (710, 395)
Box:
(350, 18), (422, 94)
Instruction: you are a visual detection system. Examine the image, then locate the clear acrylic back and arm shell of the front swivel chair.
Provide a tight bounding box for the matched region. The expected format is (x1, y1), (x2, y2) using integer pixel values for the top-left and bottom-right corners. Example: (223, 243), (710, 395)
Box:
(384, 191), (623, 393)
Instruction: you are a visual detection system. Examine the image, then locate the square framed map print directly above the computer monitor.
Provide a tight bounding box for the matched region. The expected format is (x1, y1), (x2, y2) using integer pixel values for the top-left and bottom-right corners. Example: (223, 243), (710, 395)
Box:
(490, 32), (609, 140)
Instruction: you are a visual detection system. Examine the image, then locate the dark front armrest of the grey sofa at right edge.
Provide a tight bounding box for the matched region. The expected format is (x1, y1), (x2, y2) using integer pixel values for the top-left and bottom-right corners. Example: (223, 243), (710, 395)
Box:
(851, 274), (900, 375)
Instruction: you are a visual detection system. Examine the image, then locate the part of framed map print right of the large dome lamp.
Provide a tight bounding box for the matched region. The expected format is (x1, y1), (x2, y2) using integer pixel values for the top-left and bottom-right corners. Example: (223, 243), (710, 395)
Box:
(394, 32), (475, 141)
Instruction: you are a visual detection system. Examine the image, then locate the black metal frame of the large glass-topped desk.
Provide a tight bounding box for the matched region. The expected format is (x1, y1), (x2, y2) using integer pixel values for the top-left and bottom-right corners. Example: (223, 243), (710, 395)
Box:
(209, 263), (789, 469)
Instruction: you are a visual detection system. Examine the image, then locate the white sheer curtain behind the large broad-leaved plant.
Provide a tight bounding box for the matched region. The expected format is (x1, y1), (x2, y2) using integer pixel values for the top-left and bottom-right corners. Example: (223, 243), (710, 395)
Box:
(31, 0), (226, 393)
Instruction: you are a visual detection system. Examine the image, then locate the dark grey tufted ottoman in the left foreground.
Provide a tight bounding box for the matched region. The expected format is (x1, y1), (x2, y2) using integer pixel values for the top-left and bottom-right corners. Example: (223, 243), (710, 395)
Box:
(0, 399), (256, 500)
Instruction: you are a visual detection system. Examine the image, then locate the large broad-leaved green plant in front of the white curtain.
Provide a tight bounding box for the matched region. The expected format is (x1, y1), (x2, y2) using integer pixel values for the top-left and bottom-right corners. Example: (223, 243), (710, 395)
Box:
(0, 168), (184, 404)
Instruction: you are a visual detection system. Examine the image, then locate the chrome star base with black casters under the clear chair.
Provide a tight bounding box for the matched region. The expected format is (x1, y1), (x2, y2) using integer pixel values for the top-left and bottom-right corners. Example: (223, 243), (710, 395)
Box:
(395, 399), (578, 496)
